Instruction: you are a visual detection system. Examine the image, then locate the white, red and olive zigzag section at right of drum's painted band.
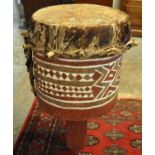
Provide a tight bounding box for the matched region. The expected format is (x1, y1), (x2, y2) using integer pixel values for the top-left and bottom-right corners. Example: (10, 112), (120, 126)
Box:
(93, 57), (120, 99)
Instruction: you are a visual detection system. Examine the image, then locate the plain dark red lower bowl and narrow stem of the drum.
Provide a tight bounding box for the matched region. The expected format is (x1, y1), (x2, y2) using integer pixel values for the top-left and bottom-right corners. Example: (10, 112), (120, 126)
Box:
(37, 97), (116, 155)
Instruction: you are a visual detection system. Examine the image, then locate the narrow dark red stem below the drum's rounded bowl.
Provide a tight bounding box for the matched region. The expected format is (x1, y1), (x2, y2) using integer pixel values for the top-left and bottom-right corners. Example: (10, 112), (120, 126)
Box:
(66, 121), (87, 155)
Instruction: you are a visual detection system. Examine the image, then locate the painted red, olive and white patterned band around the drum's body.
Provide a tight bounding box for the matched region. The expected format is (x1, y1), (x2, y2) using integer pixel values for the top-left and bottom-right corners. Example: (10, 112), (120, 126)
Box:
(33, 53), (122, 109)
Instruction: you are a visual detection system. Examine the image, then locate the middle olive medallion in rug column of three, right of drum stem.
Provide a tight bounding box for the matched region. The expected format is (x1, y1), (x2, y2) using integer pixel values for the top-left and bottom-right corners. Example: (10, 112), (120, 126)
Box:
(104, 129), (124, 141)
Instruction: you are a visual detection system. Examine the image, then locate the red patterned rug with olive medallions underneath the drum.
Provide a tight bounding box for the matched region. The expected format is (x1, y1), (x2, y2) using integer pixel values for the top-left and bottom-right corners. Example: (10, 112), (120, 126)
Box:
(14, 99), (142, 155)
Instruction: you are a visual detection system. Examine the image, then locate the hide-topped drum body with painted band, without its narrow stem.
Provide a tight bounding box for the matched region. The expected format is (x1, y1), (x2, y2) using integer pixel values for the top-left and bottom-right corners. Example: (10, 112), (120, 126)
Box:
(24, 4), (135, 120)
